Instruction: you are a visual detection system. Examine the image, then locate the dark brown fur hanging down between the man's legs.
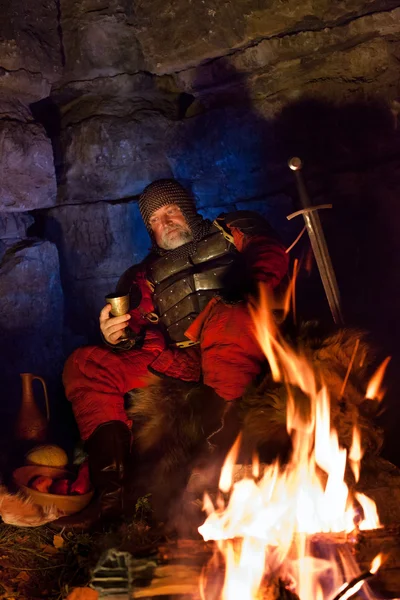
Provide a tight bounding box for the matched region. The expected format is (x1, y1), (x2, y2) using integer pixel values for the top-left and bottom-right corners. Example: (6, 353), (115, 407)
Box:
(126, 379), (220, 520)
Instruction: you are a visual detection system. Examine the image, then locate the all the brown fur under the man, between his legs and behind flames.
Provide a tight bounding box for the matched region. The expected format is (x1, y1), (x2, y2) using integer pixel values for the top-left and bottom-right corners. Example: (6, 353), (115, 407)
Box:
(126, 324), (382, 516)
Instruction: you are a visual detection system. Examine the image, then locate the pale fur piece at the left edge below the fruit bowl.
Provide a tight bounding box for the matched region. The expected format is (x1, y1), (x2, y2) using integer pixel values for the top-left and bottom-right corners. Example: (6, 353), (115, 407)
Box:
(0, 485), (60, 527)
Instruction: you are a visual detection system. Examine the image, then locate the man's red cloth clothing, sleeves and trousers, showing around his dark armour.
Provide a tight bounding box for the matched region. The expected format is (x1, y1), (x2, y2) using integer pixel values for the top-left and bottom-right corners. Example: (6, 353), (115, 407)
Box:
(63, 216), (288, 440)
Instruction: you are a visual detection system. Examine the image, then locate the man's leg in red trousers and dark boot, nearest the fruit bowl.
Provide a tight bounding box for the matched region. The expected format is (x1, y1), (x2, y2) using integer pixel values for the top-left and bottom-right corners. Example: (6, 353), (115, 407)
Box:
(58, 336), (160, 528)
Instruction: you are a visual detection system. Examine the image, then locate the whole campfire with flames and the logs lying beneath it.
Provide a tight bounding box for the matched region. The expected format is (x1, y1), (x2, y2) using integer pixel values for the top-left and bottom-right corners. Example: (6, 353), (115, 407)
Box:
(71, 290), (400, 600)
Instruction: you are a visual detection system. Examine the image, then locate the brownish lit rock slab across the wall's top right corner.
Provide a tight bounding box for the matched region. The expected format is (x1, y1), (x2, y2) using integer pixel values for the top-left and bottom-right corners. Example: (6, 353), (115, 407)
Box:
(176, 8), (400, 116)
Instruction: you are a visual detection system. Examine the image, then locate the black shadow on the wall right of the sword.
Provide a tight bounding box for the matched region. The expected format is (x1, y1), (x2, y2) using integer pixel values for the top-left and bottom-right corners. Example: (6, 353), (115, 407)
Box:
(276, 99), (400, 464)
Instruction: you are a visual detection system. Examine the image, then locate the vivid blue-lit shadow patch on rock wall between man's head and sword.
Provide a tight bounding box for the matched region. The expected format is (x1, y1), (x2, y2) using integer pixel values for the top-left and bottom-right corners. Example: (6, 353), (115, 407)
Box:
(169, 60), (296, 239)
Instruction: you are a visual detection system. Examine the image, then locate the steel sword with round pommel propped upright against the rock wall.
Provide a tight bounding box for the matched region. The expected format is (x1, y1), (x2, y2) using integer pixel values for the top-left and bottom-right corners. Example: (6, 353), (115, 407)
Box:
(287, 157), (343, 325)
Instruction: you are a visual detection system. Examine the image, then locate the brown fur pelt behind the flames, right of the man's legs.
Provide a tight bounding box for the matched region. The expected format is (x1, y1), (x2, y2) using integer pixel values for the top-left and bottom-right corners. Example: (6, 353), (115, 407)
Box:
(242, 323), (383, 452)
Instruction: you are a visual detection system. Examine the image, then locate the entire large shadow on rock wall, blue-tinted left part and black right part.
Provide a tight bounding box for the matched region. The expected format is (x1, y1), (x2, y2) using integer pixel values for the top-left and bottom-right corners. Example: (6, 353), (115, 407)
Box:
(170, 61), (400, 464)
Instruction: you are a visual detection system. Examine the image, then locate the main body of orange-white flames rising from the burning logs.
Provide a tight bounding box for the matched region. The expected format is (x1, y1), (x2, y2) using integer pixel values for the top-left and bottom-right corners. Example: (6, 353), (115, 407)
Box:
(199, 288), (384, 600)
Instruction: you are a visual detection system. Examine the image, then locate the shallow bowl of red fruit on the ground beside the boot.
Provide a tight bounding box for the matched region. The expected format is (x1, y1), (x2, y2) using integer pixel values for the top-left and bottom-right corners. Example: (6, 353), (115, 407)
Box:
(13, 464), (94, 515)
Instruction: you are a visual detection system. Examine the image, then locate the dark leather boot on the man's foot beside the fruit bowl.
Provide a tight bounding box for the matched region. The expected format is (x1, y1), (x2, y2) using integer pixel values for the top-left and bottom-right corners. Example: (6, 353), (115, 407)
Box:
(52, 421), (131, 530)
